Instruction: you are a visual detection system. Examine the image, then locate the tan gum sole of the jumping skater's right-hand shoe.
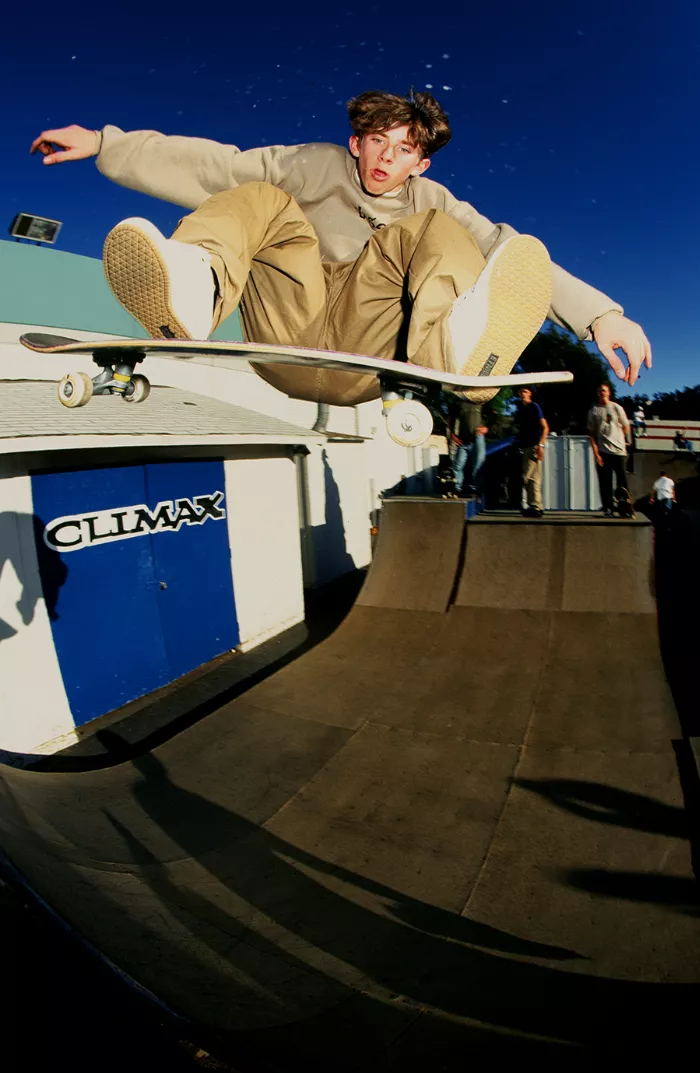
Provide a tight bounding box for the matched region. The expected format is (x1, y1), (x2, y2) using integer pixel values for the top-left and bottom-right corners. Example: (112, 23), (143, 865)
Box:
(460, 235), (552, 402)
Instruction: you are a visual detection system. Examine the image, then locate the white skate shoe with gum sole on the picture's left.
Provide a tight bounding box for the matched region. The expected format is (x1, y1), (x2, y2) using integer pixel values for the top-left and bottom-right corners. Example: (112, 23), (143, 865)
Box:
(102, 217), (216, 339)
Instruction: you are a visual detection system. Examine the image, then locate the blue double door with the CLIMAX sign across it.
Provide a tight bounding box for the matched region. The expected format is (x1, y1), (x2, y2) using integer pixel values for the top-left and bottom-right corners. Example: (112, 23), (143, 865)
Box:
(32, 461), (239, 725)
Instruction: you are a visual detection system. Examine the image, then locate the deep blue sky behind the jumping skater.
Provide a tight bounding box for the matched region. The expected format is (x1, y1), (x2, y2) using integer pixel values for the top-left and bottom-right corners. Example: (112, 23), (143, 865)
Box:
(0, 0), (700, 394)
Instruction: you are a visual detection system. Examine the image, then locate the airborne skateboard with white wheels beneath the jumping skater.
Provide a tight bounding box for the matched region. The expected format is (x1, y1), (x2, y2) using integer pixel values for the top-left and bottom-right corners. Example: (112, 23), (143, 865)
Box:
(19, 333), (573, 446)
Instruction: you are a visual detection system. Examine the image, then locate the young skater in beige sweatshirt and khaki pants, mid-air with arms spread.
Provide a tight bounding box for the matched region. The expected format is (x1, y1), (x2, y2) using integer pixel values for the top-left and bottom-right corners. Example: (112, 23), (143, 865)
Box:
(31, 91), (652, 406)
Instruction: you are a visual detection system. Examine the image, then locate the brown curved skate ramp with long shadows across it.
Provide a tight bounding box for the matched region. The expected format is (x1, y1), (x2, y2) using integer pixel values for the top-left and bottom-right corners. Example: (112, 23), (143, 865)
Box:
(0, 499), (700, 1073)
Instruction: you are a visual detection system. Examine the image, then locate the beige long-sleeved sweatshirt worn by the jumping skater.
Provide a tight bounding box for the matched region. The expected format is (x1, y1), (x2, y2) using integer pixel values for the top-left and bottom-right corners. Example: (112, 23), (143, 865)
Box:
(97, 126), (622, 339)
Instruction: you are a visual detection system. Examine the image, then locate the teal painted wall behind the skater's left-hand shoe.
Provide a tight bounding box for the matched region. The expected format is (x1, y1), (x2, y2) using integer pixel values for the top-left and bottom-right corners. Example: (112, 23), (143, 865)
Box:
(0, 241), (243, 339)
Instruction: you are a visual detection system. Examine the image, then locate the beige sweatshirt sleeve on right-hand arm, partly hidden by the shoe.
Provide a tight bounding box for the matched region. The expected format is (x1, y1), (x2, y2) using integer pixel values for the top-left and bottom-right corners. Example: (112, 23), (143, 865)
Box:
(446, 190), (623, 340)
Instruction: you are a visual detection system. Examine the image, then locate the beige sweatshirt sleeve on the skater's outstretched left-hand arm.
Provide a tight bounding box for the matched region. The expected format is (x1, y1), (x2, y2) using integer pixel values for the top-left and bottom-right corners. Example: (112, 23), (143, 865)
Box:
(97, 126), (301, 209)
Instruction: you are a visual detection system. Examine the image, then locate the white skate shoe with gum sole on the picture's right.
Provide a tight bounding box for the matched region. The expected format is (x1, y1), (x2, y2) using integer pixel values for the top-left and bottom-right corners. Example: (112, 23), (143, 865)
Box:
(448, 235), (552, 402)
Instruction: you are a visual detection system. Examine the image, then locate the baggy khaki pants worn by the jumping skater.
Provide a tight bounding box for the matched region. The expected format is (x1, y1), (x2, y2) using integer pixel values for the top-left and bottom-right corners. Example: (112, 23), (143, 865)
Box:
(173, 182), (485, 406)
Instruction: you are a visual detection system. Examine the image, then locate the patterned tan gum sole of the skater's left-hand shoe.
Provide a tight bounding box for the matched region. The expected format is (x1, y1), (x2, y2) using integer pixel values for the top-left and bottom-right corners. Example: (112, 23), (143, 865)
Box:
(102, 223), (192, 339)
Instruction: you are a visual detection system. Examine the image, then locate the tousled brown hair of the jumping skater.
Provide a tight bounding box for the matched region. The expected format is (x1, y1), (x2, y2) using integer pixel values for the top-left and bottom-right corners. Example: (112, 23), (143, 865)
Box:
(348, 89), (452, 157)
